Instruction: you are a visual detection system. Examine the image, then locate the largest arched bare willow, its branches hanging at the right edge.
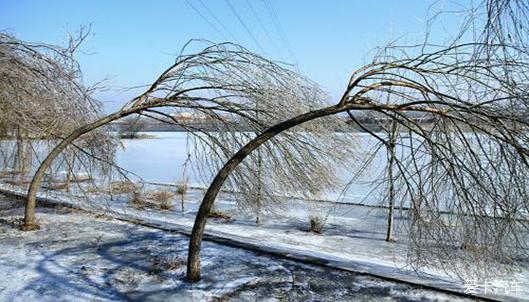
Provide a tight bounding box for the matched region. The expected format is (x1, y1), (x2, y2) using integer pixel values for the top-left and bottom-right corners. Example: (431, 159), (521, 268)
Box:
(187, 1), (529, 281)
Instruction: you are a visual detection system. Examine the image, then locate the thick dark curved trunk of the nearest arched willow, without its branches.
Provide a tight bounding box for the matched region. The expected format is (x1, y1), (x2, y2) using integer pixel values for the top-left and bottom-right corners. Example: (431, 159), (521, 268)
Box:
(187, 103), (354, 282)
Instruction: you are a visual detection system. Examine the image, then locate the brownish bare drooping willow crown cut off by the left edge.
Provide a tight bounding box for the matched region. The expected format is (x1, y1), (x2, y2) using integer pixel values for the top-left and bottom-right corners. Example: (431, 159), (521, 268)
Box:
(0, 28), (116, 217)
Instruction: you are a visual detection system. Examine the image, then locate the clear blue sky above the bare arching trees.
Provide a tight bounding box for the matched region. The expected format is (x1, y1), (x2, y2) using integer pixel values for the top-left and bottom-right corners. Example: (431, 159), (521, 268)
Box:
(0, 0), (454, 111)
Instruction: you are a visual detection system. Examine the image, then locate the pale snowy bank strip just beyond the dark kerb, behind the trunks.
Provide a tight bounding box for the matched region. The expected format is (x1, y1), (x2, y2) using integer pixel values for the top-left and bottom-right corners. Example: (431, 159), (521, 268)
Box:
(2, 185), (529, 301)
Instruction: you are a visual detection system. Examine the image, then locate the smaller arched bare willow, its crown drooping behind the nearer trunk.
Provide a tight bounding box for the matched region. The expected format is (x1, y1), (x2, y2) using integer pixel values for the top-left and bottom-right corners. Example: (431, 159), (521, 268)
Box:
(25, 41), (353, 234)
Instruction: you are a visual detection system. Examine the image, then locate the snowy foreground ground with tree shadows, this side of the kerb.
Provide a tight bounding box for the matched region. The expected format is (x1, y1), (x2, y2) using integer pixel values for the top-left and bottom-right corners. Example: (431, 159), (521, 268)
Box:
(0, 195), (465, 301)
